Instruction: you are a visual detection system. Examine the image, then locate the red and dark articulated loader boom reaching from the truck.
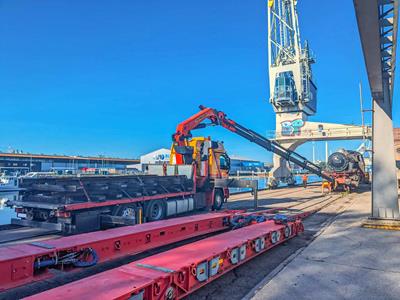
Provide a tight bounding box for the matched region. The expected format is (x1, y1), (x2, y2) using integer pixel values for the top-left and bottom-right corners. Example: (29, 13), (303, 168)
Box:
(173, 106), (334, 182)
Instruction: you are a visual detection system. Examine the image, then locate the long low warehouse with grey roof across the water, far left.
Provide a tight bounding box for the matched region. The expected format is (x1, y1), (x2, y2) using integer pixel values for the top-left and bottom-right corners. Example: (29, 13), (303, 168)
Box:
(0, 153), (139, 174)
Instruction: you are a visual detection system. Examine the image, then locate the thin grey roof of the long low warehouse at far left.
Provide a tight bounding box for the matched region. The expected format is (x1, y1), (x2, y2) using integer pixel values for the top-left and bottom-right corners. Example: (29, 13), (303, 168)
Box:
(0, 153), (139, 164)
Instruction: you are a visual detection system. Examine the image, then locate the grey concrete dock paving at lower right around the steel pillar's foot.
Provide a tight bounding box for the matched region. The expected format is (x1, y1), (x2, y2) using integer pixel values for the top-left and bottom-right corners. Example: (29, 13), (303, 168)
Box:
(250, 192), (400, 300)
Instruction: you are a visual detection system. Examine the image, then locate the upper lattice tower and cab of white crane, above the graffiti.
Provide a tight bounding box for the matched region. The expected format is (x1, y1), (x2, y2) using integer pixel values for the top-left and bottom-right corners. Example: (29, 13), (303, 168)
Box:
(268, 0), (317, 118)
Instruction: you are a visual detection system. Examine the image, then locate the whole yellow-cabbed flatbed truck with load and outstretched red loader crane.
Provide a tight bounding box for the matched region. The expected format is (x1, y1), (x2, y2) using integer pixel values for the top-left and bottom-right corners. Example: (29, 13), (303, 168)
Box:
(8, 106), (333, 233)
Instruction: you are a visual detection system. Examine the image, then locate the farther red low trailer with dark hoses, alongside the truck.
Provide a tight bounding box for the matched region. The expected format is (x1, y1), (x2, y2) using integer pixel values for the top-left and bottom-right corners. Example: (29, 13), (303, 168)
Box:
(0, 208), (300, 292)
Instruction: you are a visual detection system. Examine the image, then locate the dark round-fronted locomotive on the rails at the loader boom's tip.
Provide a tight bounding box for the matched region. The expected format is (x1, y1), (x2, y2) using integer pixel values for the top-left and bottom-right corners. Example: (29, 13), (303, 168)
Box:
(327, 149), (366, 190)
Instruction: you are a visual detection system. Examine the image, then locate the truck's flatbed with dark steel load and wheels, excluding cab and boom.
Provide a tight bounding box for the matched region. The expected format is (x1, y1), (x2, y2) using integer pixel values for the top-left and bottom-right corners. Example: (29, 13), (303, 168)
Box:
(7, 164), (229, 234)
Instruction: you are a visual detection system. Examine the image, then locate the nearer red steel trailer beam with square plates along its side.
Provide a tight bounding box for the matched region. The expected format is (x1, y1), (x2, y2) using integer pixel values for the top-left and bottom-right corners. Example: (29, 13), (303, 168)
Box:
(27, 220), (304, 300)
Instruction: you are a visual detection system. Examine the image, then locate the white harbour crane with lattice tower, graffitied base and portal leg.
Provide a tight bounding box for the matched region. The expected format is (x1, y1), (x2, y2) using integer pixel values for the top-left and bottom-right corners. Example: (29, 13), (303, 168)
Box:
(268, 0), (371, 186)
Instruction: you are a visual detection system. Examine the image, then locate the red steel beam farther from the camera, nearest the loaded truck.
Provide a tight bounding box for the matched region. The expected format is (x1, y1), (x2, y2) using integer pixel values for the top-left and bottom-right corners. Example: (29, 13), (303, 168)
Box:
(0, 212), (233, 291)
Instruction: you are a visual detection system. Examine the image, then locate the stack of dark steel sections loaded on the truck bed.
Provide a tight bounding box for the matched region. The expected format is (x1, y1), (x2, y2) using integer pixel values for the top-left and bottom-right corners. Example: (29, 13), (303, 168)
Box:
(20, 175), (193, 204)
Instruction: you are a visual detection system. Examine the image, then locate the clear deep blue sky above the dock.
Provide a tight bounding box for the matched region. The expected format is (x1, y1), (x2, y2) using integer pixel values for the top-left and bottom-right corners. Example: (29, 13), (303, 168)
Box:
(0, 0), (400, 160)
